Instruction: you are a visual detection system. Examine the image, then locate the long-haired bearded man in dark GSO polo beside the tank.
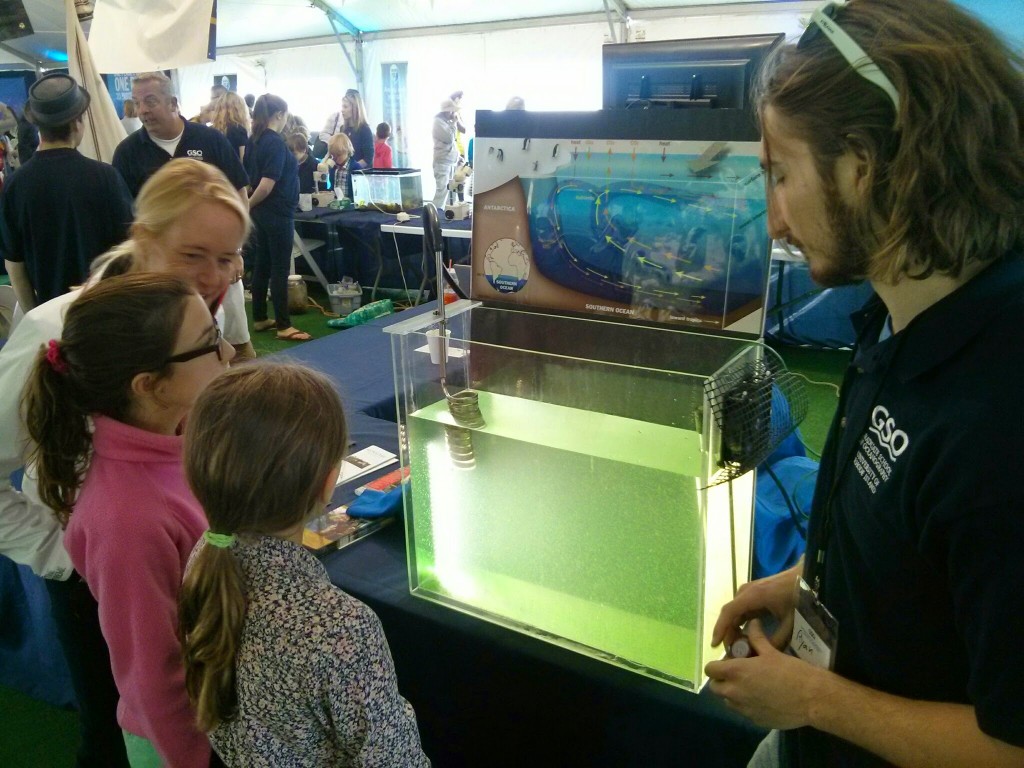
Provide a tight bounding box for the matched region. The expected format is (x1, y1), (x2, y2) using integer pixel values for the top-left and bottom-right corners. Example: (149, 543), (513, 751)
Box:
(707, 0), (1024, 766)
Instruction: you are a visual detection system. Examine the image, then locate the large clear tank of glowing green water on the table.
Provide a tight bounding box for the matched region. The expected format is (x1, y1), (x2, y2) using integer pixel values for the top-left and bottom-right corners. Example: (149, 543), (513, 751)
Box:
(387, 300), (763, 691)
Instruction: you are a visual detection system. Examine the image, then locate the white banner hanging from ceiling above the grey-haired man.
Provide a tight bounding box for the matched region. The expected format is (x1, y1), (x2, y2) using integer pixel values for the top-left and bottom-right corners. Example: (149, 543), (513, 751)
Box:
(89, 0), (216, 73)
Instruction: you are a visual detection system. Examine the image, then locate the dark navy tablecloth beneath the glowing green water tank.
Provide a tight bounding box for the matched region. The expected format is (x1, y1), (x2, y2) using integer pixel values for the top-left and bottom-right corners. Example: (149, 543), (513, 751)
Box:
(278, 305), (764, 767)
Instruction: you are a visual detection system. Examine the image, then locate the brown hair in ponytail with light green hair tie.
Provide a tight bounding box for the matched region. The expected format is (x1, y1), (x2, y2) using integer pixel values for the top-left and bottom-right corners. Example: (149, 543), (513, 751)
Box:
(178, 362), (347, 731)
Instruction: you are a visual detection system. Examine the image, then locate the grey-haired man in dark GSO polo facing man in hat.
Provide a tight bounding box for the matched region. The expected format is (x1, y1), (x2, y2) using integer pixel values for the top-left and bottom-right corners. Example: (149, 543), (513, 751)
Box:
(113, 72), (256, 360)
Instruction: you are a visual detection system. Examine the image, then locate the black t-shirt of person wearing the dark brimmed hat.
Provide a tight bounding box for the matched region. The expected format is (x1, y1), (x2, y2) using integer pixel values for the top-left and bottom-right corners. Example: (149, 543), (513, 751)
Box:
(0, 148), (132, 304)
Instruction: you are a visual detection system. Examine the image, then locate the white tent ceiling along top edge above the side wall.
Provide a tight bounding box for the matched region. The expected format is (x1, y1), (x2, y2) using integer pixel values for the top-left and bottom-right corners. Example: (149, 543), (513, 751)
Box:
(0, 0), (800, 69)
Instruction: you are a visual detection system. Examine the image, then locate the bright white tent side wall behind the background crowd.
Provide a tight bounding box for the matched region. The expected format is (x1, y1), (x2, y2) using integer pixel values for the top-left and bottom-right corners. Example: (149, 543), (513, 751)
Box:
(179, 4), (802, 198)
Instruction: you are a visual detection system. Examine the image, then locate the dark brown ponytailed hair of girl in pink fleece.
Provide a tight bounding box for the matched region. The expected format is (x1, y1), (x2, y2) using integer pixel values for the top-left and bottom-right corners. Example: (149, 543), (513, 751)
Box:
(22, 272), (196, 525)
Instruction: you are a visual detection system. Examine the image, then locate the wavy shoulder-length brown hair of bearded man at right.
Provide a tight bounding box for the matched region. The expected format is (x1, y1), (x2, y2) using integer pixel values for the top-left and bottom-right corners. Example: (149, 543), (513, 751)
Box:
(756, 0), (1024, 283)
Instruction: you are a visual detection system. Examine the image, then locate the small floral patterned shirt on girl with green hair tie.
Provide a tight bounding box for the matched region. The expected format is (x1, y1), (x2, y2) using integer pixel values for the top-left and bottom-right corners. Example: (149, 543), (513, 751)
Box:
(194, 537), (430, 768)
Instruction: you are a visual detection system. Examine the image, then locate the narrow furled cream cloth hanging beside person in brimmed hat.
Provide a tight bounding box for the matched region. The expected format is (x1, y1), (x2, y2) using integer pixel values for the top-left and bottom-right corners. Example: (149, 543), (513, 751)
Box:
(65, 0), (127, 163)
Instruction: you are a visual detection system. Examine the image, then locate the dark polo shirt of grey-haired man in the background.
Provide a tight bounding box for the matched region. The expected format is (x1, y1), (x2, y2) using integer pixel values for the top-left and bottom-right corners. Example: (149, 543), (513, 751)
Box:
(113, 122), (249, 198)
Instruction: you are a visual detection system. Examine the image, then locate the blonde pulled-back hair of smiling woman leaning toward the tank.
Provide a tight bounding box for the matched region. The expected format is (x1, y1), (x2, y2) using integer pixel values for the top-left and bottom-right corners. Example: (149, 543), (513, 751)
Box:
(92, 158), (252, 275)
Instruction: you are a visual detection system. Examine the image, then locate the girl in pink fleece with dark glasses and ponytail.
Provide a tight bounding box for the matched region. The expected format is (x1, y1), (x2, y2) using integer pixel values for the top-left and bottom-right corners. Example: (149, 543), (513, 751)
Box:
(23, 272), (234, 768)
